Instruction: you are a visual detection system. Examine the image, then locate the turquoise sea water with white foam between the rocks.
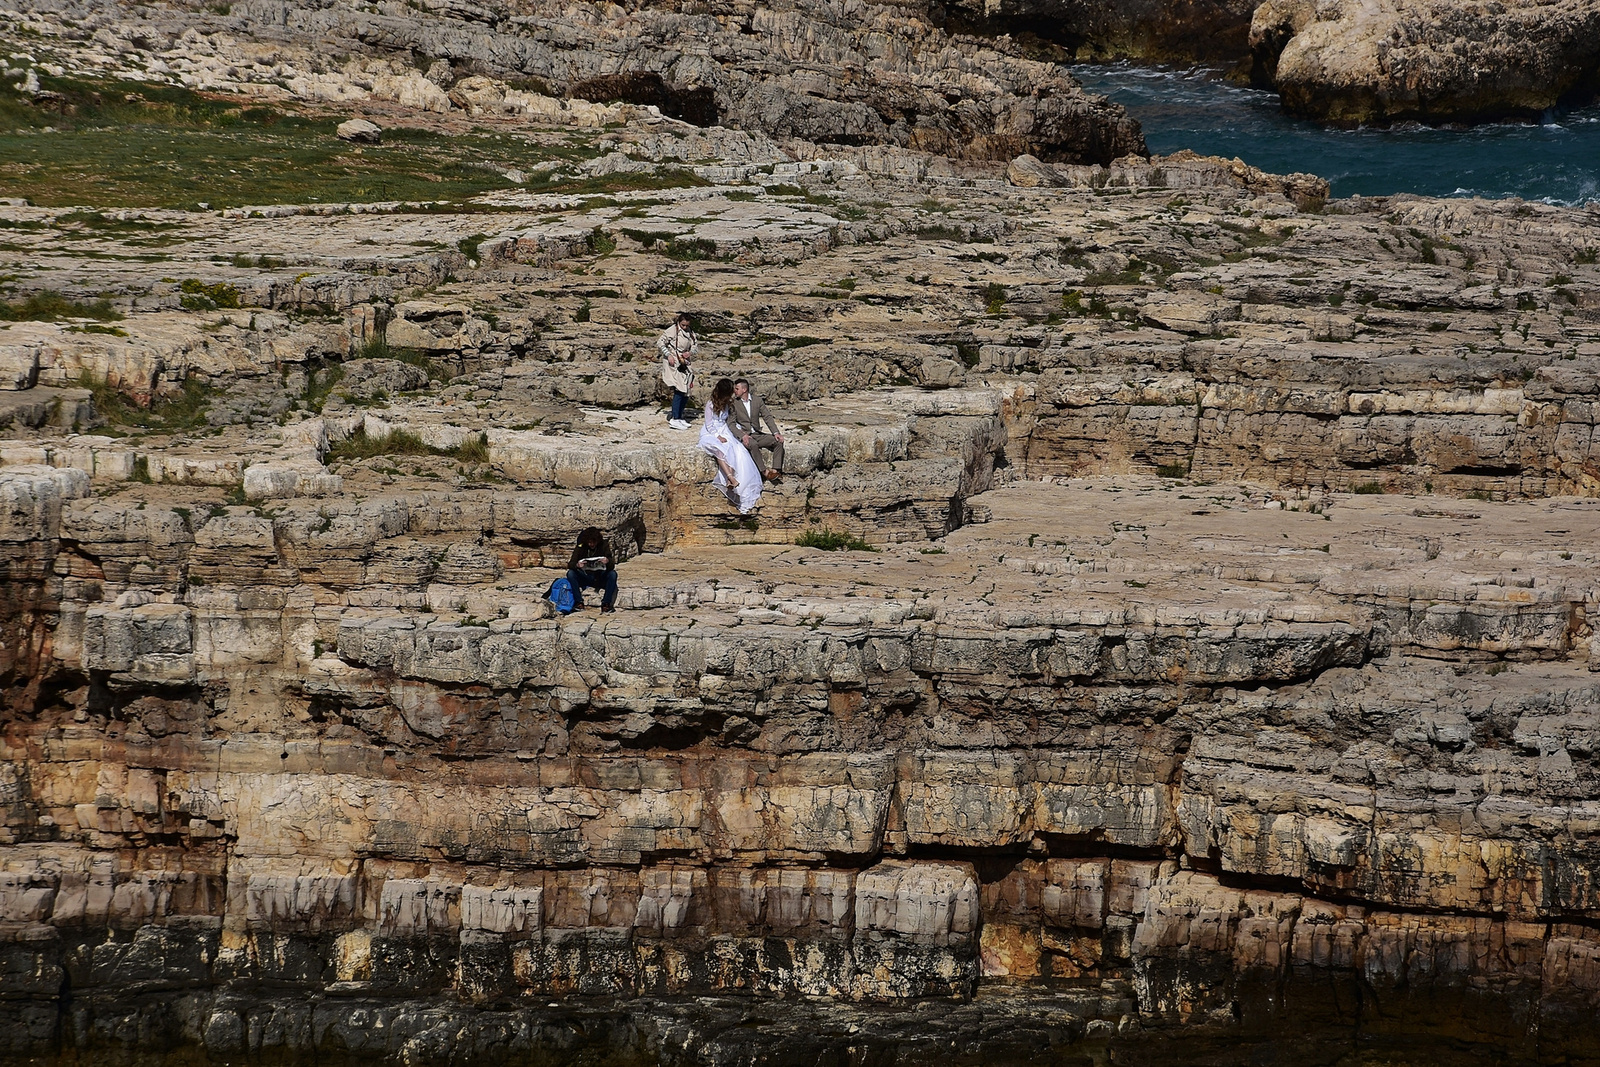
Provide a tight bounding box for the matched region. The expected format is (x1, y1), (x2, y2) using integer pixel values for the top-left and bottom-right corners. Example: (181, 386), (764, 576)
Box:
(1072, 64), (1600, 203)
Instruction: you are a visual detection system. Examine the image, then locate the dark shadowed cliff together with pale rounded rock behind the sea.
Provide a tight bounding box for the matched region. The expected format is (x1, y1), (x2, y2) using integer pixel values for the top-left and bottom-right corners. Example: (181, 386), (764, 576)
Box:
(950, 0), (1600, 126)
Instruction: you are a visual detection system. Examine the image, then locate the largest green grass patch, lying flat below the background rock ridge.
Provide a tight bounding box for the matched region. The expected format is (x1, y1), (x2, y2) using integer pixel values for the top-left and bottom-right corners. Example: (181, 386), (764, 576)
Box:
(0, 75), (640, 207)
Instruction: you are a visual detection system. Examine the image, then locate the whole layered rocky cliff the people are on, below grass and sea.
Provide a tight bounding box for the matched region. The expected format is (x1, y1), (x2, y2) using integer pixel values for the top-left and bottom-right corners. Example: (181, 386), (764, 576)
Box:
(0, 4), (1600, 1064)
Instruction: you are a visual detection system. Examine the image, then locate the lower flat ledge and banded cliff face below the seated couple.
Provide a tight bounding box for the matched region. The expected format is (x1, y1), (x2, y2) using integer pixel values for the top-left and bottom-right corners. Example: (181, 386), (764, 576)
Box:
(0, 467), (1600, 1064)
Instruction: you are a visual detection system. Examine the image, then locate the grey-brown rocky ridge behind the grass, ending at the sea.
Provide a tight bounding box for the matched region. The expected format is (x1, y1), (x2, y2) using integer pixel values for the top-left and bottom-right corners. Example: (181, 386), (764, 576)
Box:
(0, 0), (1144, 163)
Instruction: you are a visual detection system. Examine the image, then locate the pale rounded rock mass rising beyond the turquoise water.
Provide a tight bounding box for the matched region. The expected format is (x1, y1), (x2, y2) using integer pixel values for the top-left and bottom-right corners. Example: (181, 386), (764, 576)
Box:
(1250, 0), (1600, 125)
